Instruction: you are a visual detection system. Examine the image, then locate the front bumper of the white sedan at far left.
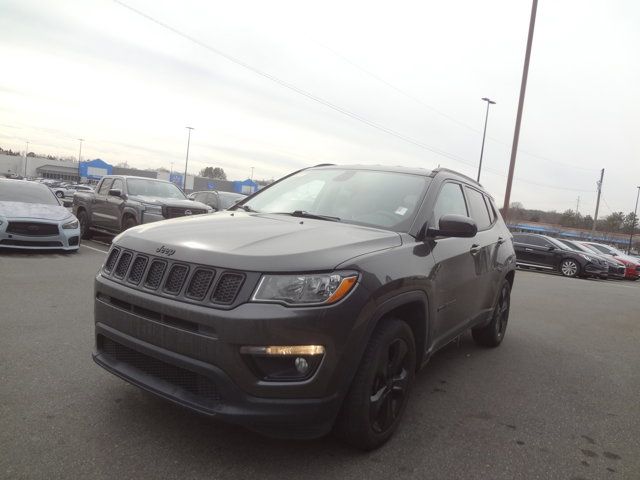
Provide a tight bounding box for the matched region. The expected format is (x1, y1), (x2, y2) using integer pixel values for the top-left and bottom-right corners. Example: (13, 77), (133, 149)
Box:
(0, 218), (80, 251)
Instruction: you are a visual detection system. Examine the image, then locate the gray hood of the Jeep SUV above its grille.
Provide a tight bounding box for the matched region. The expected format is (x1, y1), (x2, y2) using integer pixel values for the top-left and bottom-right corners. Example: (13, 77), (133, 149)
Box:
(114, 211), (402, 272)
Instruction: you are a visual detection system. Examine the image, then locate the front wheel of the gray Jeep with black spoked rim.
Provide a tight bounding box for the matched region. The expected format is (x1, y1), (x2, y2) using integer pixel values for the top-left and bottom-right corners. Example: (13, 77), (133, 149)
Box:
(335, 318), (416, 450)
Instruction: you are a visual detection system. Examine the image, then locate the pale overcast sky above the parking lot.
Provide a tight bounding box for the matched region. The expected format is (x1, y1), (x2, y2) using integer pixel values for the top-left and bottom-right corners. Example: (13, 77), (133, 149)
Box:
(0, 0), (640, 215)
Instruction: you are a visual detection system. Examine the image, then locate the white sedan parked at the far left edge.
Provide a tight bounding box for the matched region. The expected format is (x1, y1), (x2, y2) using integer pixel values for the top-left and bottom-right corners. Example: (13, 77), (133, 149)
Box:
(0, 179), (80, 251)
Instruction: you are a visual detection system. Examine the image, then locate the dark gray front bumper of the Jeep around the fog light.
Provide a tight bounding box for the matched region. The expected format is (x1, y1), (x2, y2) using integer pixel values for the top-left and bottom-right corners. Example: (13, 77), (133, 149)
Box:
(94, 275), (367, 438)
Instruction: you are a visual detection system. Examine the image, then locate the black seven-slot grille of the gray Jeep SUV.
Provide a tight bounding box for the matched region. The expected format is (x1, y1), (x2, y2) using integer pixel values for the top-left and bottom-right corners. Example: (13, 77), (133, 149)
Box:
(102, 247), (246, 308)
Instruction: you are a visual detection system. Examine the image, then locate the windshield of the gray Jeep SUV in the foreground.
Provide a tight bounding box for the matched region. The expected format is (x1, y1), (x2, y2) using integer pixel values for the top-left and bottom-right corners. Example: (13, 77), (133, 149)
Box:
(234, 168), (430, 231)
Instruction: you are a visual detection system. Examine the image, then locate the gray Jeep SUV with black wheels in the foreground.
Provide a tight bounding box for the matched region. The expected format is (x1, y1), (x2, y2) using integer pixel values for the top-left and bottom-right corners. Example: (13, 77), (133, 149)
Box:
(94, 165), (515, 449)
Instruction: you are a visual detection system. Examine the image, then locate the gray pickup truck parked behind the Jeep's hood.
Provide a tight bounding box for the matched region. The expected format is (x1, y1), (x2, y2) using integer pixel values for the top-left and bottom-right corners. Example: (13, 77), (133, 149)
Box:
(73, 175), (213, 239)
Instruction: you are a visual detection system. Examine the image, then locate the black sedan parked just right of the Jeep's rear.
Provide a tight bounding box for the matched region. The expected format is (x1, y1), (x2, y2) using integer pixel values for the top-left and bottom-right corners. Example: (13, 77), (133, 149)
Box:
(513, 233), (609, 278)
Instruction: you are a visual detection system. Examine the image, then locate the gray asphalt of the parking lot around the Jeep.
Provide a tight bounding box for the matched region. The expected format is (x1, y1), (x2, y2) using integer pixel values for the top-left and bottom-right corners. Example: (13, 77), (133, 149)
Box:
(0, 246), (640, 480)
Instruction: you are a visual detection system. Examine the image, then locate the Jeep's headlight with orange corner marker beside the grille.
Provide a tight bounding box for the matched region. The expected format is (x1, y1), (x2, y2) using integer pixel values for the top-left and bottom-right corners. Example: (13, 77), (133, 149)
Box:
(252, 272), (358, 305)
